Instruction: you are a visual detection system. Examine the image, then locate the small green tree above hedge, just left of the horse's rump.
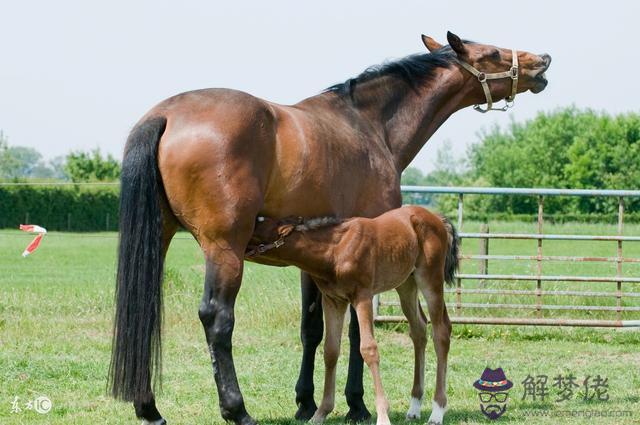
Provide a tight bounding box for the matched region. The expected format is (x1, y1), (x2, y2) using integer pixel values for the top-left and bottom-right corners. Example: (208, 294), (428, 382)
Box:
(64, 148), (120, 182)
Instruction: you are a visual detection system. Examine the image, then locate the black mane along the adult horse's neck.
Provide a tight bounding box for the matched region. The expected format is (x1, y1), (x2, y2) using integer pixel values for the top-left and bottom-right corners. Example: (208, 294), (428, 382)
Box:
(325, 46), (455, 97)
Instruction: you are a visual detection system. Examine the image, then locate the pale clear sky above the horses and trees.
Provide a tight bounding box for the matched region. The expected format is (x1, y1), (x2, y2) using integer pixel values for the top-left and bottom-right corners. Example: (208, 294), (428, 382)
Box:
(0, 0), (640, 172)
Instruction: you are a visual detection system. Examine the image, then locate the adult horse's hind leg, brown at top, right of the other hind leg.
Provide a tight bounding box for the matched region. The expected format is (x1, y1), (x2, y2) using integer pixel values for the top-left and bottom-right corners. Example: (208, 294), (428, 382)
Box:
(198, 240), (256, 425)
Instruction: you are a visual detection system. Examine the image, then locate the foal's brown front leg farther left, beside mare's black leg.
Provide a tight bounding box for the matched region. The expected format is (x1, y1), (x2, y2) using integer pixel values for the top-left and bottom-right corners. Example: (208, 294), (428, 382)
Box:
(311, 295), (347, 423)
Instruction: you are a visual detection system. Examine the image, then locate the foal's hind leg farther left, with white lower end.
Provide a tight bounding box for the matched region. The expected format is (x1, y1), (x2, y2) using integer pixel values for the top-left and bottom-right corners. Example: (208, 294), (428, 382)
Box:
(396, 276), (427, 419)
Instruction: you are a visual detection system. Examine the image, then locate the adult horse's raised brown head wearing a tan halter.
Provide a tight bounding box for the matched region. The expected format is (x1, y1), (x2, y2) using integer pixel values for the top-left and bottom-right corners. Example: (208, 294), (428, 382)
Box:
(422, 32), (551, 112)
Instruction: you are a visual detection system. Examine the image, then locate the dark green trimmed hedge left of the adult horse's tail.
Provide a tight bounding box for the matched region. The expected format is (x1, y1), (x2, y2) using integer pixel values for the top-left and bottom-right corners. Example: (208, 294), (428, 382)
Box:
(0, 186), (119, 232)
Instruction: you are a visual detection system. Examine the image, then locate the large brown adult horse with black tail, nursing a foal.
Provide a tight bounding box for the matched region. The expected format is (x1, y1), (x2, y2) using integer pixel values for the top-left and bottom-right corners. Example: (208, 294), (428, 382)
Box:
(110, 33), (551, 424)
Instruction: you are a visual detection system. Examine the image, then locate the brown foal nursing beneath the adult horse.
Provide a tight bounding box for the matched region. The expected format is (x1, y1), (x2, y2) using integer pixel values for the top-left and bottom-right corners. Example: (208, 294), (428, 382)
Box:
(248, 206), (458, 425)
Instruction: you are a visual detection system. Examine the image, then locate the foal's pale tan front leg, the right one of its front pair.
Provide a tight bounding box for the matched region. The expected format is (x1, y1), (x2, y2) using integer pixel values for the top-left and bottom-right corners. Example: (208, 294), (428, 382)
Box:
(354, 294), (391, 425)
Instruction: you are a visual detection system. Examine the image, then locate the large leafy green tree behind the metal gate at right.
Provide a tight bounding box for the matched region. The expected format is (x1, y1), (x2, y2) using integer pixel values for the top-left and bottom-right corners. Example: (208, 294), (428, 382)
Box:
(469, 107), (640, 214)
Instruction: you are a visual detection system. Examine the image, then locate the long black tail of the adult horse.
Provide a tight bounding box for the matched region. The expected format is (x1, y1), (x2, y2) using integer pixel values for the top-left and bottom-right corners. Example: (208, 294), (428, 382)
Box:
(109, 117), (167, 401)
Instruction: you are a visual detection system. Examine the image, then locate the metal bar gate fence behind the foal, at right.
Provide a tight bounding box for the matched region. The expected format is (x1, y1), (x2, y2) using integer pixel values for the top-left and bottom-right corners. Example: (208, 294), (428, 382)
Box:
(374, 186), (640, 327)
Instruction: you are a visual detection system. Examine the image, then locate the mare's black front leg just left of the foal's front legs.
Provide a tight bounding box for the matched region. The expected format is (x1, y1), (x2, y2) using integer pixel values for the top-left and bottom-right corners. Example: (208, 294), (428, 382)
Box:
(295, 272), (323, 421)
